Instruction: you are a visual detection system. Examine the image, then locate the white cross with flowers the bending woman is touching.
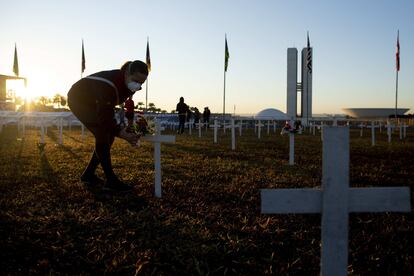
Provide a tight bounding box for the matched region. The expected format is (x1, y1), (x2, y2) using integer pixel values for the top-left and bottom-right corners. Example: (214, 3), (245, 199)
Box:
(141, 122), (175, 198)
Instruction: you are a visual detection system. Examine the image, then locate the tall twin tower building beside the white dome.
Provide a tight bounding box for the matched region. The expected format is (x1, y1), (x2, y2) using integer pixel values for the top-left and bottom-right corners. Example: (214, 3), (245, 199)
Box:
(286, 47), (312, 125)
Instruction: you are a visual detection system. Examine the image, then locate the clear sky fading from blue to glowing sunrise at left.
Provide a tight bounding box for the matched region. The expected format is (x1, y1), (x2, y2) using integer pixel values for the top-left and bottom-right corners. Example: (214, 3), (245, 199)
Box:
(0, 0), (414, 114)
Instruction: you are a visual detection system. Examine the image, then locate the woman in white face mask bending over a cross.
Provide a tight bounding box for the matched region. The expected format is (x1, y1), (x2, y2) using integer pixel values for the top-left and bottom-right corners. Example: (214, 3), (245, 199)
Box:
(68, 60), (148, 191)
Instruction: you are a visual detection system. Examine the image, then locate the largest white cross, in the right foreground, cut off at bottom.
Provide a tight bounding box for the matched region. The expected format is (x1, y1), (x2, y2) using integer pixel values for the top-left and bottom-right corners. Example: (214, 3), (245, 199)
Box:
(261, 127), (411, 276)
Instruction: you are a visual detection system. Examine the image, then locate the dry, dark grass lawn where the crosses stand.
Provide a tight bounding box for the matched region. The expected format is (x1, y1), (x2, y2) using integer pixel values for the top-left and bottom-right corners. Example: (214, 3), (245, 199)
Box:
(0, 126), (414, 275)
